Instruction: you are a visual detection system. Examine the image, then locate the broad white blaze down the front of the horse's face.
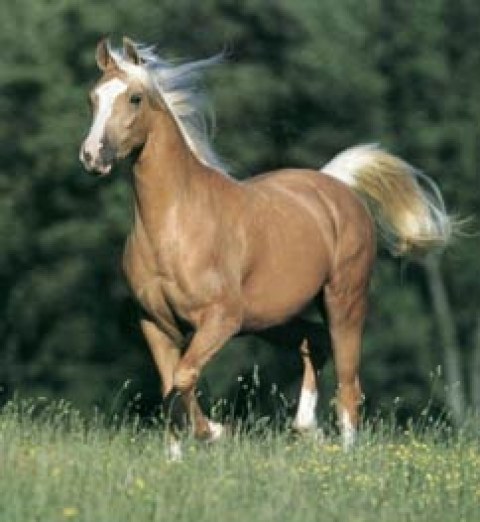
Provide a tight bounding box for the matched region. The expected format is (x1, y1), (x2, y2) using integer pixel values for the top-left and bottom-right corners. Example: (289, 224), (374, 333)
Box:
(83, 78), (127, 163)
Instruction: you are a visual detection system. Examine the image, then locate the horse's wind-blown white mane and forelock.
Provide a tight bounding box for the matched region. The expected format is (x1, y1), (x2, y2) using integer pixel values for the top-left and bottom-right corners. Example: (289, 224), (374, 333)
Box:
(109, 43), (226, 172)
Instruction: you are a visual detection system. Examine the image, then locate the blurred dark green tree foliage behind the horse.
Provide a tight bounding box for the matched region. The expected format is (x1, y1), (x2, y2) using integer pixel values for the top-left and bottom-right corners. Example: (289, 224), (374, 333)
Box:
(0, 0), (480, 417)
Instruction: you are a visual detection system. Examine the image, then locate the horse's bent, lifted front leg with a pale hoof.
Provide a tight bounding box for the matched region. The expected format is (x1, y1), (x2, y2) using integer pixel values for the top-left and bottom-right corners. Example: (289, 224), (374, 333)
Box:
(171, 304), (241, 440)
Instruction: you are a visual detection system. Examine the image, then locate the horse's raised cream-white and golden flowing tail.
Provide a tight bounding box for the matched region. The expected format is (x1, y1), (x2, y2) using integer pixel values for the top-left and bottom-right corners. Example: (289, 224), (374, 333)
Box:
(321, 145), (453, 255)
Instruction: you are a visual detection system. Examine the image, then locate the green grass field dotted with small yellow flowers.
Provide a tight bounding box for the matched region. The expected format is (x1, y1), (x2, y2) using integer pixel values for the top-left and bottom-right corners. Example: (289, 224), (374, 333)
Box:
(0, 403), (480, 522)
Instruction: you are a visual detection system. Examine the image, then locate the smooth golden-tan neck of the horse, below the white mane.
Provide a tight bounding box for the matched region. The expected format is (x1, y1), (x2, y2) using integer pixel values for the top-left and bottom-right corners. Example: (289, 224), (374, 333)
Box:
(133, 114), (221, 237)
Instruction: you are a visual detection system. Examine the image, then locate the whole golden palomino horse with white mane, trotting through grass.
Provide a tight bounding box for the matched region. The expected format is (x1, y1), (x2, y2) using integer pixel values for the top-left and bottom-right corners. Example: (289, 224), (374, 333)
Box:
(80, 39), (451, 456)
